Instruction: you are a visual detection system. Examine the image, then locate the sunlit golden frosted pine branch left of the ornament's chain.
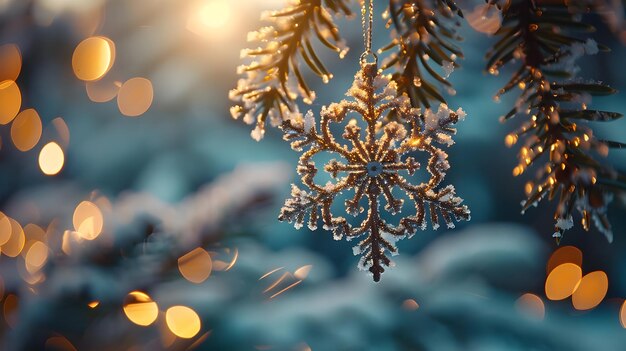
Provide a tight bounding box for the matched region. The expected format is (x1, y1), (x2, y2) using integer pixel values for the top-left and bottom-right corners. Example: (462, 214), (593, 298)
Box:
(230, 0), (352, 140)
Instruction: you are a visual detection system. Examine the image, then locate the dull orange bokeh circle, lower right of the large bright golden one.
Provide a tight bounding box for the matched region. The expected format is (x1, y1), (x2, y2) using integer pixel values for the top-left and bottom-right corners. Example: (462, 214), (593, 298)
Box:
(117, 77), (154, 117)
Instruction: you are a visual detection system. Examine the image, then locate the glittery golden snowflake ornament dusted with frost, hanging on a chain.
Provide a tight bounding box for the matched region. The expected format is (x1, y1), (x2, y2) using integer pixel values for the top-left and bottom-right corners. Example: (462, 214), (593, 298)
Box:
(279, 63), (470, 281)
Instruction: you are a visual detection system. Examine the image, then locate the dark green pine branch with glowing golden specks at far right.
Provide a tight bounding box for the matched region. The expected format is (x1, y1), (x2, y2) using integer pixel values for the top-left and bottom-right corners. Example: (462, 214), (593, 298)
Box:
(487, 0), (626, 241)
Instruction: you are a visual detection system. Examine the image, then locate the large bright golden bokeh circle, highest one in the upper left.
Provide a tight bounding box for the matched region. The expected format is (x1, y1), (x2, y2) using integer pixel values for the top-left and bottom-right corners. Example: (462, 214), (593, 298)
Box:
(72, 36), (115, 82)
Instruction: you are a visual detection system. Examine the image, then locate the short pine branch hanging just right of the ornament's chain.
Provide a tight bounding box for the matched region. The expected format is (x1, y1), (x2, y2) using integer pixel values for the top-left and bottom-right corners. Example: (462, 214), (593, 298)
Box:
(379, 0), (463, 108)
